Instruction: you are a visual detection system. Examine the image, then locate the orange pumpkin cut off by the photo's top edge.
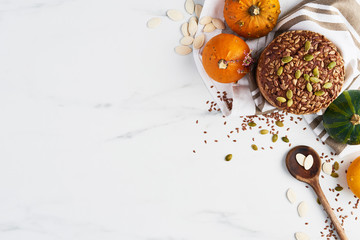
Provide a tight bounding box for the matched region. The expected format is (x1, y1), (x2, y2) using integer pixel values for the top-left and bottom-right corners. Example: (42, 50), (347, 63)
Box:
(224, 0), (280, 38)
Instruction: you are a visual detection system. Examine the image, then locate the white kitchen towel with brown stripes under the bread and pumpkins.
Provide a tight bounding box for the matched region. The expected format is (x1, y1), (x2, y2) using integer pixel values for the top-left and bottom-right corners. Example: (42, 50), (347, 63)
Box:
(194, 0), (360, 154)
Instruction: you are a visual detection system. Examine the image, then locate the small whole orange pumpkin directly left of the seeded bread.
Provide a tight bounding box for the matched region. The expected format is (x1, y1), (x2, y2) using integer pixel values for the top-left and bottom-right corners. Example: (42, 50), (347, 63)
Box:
(202, 33), (252, 83)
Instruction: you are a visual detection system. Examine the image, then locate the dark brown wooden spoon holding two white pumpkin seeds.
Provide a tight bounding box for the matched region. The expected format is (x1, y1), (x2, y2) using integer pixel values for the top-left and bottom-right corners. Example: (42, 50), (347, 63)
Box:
(286, 146), (348, 240)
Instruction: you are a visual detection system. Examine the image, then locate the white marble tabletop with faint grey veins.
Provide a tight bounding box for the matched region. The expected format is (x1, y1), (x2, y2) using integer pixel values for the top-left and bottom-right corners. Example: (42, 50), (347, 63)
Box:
(0, 0), (360, 240)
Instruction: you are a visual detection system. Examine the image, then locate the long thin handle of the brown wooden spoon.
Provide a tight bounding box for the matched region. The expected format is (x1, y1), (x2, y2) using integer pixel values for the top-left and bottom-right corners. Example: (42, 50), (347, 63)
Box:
(311, 181), (348, 240)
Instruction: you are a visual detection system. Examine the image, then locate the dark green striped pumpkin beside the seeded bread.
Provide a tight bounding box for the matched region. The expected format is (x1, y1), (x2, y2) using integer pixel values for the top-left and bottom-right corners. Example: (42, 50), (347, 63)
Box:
(323, 90), (360, 145)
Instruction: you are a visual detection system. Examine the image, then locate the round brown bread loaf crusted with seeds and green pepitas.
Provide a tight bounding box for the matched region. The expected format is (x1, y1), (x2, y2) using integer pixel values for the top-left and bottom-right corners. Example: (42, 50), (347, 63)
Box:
(256, 30), (345, 114)
